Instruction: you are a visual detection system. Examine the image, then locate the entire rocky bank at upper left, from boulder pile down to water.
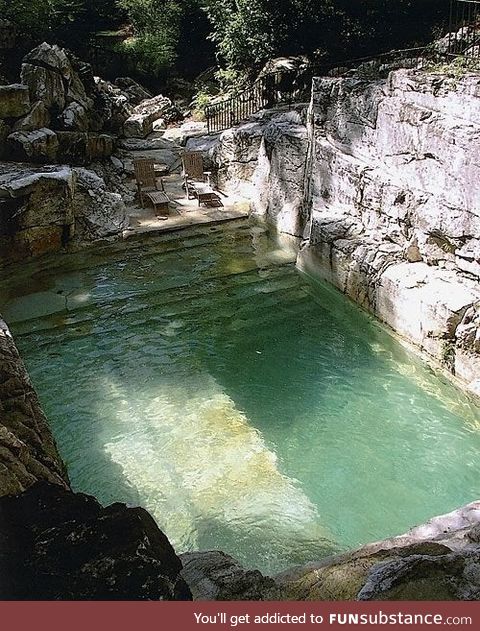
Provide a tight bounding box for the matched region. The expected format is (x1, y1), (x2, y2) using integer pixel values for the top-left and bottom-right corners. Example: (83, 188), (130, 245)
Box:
(0, 42), (186, 262)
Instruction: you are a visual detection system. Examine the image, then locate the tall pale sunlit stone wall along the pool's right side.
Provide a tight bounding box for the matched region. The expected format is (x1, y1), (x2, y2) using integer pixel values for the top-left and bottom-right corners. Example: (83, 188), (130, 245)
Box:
(212, 70), (480, 394)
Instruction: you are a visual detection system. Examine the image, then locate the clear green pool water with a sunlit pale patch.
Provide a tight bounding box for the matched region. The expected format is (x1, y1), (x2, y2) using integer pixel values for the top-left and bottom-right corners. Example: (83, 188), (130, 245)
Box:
(0, 223), (480, 572)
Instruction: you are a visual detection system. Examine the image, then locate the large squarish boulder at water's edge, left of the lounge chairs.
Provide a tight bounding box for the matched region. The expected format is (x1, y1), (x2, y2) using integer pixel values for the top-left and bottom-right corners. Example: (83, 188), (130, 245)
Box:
(0, 162), (128, 263)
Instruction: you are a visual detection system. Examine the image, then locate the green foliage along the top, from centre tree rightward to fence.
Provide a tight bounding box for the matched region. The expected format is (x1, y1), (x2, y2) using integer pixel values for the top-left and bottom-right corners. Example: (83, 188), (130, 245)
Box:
(199, 0), (449, 79)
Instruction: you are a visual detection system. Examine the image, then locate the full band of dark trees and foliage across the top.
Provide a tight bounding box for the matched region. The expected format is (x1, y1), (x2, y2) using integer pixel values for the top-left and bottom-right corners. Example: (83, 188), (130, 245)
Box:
(0, 0), (449, 85)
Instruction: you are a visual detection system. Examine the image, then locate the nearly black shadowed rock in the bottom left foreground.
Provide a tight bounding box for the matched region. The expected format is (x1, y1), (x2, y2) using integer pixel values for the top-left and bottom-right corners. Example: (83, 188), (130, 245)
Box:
(0, 482), (191, 600)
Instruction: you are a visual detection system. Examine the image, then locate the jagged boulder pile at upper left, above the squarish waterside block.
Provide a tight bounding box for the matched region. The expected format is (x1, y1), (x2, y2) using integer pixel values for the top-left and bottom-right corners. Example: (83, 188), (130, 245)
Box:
(0, 42), (181, 166)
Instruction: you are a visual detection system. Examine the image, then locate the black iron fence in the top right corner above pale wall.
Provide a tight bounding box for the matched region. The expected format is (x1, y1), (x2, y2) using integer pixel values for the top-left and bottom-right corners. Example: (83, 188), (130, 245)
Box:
(447, 0), (480, 58)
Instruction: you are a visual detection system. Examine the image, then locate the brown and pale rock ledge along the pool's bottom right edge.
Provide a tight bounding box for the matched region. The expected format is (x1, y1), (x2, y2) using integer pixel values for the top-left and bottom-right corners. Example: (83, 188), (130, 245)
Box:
(181, 502), (480, 601)
